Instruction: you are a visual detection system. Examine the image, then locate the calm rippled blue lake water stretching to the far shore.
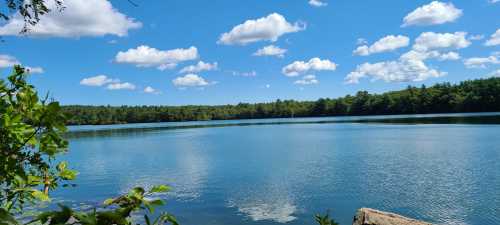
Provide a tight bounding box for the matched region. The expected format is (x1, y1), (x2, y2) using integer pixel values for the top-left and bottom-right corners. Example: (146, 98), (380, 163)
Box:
(55, 114), (500, 225)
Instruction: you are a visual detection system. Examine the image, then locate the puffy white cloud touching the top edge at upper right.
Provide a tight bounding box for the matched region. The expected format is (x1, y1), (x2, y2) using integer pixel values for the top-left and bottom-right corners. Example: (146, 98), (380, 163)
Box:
(402, 1), (463, 27)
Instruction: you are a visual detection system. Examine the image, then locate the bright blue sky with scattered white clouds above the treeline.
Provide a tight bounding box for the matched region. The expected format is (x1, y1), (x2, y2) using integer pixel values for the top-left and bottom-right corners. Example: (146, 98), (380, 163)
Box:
(0, 0), (500, 105)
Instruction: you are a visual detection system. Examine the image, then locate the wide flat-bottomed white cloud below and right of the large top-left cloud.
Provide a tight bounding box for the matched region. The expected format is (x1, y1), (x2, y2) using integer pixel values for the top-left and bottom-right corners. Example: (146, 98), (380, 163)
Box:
(115, 45), (198, 70)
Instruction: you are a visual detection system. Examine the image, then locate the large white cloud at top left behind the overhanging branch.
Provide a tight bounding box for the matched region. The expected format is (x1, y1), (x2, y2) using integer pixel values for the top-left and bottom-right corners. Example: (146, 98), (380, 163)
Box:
(0, 0), (142, 37)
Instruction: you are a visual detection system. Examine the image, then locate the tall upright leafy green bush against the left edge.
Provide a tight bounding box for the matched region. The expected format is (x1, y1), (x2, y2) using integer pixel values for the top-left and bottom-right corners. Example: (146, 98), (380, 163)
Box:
(0, 66), (73, 211)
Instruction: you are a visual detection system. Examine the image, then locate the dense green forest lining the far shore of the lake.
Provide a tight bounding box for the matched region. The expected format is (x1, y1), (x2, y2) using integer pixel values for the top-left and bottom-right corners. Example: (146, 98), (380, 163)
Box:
(63, 78), (500, 124)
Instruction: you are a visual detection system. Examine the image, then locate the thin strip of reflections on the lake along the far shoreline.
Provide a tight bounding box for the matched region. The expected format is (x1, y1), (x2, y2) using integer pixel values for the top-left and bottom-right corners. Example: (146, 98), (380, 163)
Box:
(66, 112), (500, 138)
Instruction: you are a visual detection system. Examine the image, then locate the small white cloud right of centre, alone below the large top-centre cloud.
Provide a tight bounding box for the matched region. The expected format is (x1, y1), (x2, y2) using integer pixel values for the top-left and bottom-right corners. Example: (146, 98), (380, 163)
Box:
(281, 58), (337, 77)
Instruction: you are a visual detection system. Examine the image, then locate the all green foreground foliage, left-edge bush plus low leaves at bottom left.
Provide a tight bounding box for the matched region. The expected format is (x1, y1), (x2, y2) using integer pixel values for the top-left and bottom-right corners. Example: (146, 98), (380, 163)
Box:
(0, 66), (178, 225)
